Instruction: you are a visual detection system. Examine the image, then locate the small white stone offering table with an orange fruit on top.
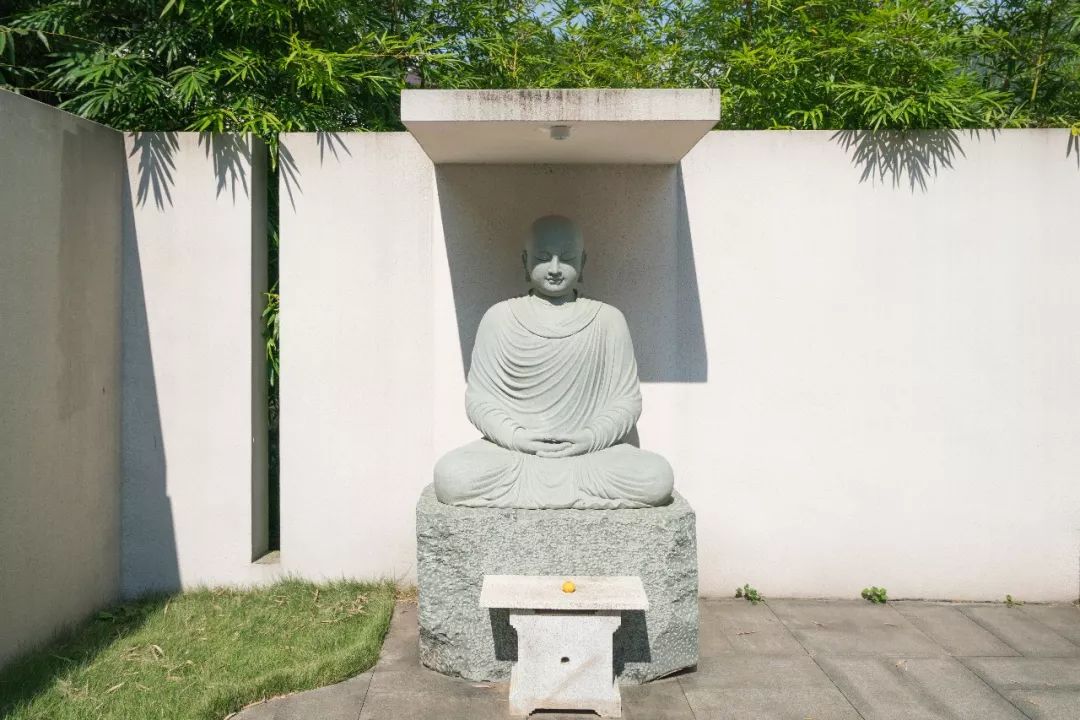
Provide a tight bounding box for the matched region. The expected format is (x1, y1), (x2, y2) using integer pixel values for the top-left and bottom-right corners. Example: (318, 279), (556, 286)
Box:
(480, 575), (649, 718)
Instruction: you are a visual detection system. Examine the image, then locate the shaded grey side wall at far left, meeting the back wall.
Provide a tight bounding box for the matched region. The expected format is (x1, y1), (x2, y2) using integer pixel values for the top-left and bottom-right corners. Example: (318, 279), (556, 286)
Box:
(0, 91), (123, 665)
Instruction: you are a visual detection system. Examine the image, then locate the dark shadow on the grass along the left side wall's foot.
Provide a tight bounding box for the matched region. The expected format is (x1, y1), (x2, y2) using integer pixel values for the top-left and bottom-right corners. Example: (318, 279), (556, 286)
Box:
(0, 595), (173, 718)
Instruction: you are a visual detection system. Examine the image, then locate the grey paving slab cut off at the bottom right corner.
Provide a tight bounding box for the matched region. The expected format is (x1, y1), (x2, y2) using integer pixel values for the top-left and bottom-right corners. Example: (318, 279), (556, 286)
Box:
(962, 657), (1080, 720)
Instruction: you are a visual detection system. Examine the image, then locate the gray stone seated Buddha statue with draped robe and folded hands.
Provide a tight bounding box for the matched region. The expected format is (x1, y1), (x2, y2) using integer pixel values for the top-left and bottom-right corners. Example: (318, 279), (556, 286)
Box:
(435, 215), (673, 510)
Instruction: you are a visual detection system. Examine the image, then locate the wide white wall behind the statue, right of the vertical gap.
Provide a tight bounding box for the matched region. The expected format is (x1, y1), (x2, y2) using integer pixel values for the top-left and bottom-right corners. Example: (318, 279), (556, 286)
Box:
(281, 131), (1080, 599)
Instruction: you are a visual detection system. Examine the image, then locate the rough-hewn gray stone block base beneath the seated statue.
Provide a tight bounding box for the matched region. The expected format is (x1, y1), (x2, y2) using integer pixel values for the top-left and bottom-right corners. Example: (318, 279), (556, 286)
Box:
(416, 486), (698, 683)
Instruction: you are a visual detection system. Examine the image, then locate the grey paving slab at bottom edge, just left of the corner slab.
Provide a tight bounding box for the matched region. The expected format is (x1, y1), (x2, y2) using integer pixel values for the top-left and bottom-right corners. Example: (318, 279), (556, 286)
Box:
(815, 655), (1024, 720)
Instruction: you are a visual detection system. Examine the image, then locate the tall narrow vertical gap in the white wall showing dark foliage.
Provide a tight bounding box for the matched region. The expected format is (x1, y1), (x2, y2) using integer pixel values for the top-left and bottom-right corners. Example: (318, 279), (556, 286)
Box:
(264, 155), (281, 553)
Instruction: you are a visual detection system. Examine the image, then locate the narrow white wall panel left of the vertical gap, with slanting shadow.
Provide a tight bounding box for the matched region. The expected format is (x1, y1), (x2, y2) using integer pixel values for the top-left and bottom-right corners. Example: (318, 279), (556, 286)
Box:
(122, 133), (267, 596)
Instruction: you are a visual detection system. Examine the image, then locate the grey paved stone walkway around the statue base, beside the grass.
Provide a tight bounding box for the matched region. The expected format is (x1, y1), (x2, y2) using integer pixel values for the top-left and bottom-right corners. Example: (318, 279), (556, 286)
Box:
(233, 599), (1080, 720)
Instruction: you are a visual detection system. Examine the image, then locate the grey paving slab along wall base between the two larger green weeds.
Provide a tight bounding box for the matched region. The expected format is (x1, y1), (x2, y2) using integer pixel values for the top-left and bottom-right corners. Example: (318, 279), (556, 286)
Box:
(769, 600), (946, 657)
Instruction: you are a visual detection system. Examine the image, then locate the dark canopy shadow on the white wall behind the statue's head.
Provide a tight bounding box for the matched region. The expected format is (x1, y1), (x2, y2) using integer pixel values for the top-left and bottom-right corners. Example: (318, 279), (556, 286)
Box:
(435, 165), (708, 382)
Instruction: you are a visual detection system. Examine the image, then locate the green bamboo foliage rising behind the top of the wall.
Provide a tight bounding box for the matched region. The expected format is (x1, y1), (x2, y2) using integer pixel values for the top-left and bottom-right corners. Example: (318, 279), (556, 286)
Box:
(0, 0), (1080, 134)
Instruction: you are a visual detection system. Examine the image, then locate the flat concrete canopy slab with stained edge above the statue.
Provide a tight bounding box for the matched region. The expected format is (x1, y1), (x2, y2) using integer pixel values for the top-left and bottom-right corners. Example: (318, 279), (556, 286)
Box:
(402, 90), (720, 165)
